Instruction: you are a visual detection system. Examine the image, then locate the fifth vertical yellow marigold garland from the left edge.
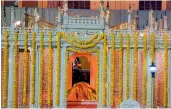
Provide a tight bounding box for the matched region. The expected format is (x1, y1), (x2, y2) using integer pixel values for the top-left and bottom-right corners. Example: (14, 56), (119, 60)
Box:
(39, 32), (44, 106)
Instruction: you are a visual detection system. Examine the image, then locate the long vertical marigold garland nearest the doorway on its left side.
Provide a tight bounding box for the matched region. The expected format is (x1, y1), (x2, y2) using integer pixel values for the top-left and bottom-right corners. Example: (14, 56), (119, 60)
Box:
(56, 32), (61, 106)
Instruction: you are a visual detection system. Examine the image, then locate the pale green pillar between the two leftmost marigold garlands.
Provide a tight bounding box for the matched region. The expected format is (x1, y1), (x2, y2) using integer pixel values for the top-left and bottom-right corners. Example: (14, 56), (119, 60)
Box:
(7, 42), (14, 108)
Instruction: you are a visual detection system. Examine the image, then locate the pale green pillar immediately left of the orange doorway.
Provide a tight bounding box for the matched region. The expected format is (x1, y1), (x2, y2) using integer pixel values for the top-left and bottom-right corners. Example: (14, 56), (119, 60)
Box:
(58, 45), (67, 108)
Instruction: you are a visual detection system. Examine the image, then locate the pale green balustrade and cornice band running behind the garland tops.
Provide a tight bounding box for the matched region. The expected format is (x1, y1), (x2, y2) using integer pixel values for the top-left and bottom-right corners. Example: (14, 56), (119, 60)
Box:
(1, 27), (171, 48)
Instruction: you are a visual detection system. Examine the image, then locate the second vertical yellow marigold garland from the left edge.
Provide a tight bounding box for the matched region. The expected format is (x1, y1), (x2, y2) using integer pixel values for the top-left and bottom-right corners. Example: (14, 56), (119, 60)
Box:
(13, 32), (18, 108)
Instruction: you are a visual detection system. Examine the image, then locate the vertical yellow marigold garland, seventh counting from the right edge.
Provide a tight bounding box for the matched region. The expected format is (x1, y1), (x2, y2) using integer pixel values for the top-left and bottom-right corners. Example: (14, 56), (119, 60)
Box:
(110, 34), (115, 106)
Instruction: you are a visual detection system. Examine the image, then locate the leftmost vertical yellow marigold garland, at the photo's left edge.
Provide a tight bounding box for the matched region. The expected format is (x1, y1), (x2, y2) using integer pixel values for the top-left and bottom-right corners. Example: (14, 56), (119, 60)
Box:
(2, 31), (9, 108)
